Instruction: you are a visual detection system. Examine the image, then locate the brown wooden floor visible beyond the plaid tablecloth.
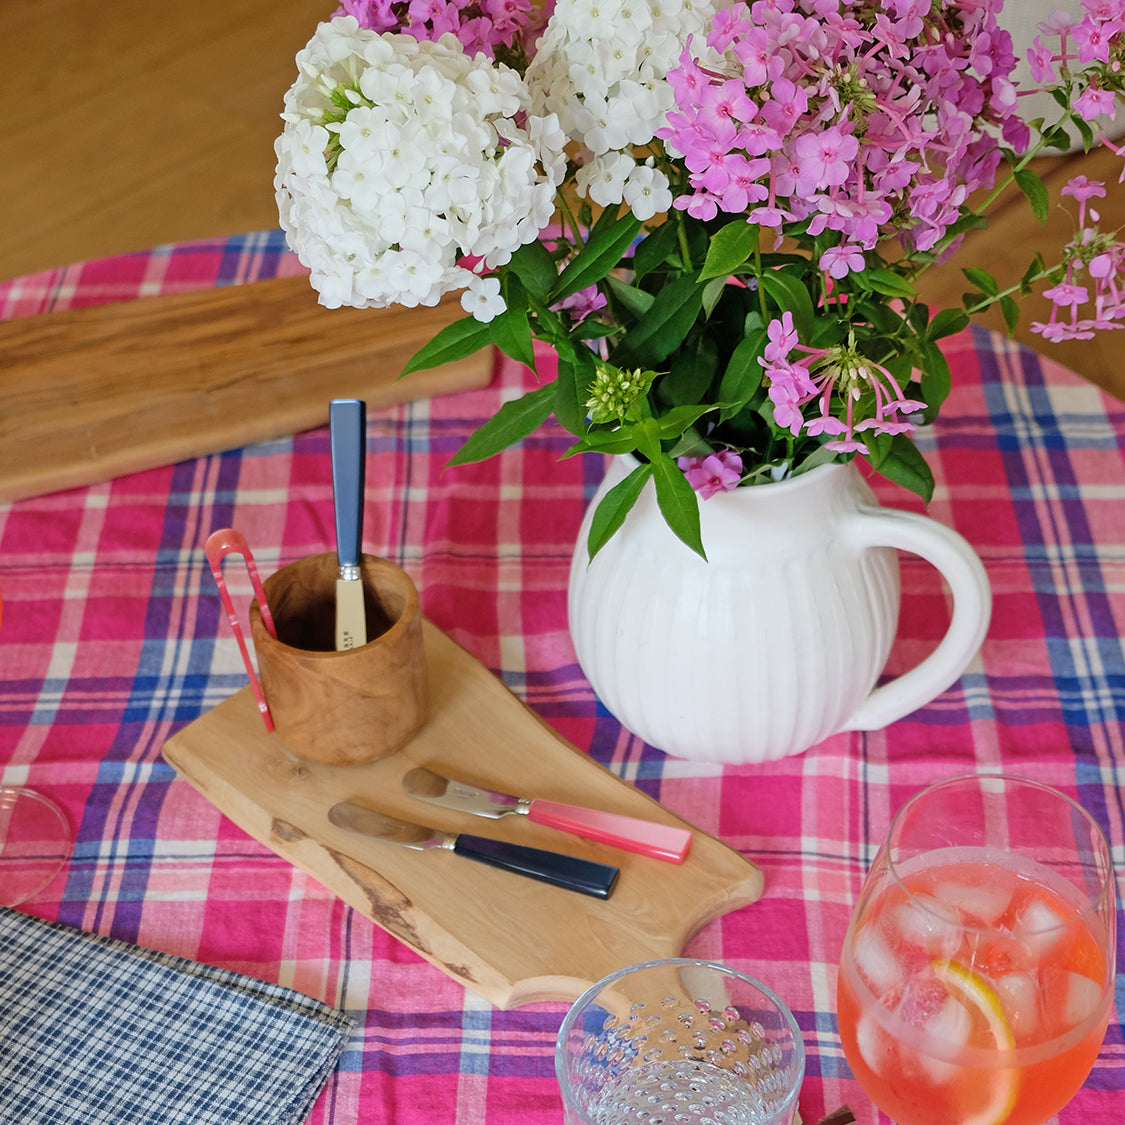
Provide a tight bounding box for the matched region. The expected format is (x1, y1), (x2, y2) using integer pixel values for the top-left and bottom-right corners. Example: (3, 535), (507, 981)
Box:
(0, 0), (1125, 397)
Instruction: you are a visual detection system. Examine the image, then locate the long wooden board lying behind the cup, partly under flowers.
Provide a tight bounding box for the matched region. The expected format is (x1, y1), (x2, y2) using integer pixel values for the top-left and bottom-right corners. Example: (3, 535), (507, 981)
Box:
(0, 275), (493, 502)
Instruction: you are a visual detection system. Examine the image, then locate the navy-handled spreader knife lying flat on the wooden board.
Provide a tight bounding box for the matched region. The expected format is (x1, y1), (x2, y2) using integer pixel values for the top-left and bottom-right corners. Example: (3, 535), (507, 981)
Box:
(329, 801), (620, 899)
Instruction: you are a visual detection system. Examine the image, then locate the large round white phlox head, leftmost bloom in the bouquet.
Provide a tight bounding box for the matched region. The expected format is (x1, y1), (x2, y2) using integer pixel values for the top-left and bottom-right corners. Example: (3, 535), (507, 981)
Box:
(275, 16), (566, 320)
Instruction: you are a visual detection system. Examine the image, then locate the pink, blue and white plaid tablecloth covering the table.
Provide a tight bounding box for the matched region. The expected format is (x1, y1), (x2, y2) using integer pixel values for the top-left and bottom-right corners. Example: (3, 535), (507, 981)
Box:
(0, 233), (1125, 1125)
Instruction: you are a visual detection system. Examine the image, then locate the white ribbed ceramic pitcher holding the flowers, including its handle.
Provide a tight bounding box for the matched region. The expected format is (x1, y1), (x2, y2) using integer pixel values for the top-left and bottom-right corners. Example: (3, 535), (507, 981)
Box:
(568, 457), (991, 763)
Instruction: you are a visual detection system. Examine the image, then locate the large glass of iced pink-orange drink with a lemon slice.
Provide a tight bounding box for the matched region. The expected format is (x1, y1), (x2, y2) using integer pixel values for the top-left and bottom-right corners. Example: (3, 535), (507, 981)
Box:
(837, 776), (1116, 1125)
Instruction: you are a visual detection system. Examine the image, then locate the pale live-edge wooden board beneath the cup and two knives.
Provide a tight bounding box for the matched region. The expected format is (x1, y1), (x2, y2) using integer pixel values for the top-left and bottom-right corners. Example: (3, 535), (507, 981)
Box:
(163, 621), (762, 1008)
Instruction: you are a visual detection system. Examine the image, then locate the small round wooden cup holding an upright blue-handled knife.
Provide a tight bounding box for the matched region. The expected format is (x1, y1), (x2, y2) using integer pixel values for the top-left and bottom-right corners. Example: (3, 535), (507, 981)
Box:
(250, 552), (426, 766)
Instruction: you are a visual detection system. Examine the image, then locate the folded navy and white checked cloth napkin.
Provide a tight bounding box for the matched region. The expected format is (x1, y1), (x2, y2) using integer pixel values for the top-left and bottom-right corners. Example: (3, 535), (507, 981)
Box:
(0, 909), (352, 1125)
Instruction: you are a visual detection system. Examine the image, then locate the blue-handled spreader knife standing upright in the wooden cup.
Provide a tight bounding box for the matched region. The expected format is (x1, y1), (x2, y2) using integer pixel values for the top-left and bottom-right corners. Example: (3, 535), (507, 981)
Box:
(329, 398), (367, 651)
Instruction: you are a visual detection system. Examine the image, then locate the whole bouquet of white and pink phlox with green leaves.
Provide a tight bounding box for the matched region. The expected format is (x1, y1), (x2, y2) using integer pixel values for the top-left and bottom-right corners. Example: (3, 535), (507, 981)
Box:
(276, 0), (1125, 554)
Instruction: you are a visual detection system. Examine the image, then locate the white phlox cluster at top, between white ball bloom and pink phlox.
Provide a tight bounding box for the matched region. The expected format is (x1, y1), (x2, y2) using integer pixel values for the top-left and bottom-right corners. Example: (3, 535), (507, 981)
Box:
(527, 0), (719, 218)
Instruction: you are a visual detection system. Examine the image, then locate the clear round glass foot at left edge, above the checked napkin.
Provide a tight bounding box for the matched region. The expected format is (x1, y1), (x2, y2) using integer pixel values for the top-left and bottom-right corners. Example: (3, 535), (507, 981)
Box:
(0, 602), (73, 907)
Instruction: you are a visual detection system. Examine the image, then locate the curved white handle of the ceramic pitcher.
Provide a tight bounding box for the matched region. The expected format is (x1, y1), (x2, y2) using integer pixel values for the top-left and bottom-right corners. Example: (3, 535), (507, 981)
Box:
(840, 507), (992, 730)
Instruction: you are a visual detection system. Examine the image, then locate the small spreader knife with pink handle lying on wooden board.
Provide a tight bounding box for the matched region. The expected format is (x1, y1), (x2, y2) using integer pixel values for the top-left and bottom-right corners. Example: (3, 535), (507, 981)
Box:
(403, 766), (692, 863)
